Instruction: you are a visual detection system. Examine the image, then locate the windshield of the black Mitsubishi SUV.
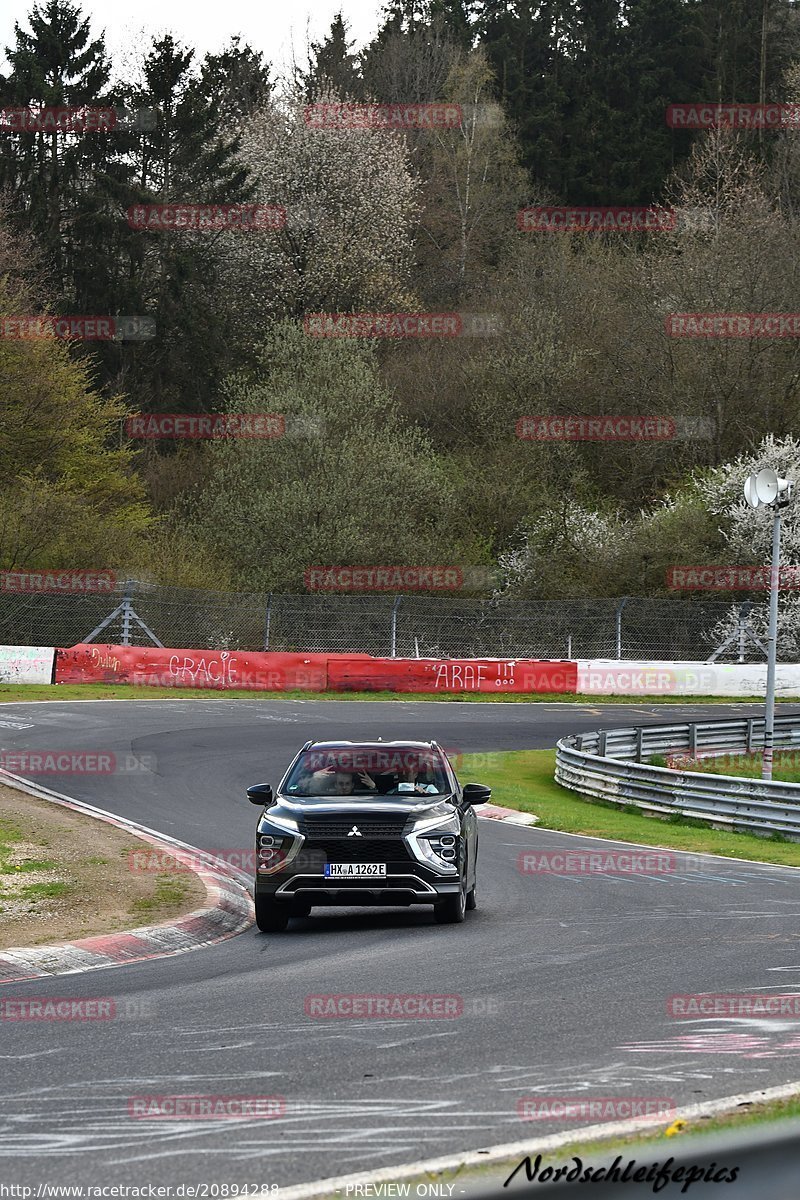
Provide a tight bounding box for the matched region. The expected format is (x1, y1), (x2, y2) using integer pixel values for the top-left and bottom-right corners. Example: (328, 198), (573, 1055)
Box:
(282, 745), (452, 799)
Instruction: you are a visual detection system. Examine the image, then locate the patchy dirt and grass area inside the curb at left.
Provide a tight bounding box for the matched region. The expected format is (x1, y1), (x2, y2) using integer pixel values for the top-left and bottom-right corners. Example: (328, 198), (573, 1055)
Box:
(0, 786), (205, 950)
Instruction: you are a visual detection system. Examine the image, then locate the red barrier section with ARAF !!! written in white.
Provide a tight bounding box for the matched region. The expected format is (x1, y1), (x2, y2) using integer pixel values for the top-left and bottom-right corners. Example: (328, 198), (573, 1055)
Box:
(327, 659), (578, 694)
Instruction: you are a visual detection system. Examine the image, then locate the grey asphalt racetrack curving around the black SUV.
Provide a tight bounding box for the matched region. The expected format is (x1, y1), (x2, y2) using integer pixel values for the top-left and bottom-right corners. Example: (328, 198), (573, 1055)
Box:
(0, 700), (800, 1187)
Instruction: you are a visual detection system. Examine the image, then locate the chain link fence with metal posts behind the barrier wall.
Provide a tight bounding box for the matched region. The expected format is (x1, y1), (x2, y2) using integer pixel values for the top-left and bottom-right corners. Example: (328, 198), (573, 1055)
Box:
(0, 581), (765, 662)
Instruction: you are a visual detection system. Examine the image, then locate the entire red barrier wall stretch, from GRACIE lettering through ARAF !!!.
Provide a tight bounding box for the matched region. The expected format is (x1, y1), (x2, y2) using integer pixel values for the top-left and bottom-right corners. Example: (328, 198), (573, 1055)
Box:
(55, 643), (578, 694)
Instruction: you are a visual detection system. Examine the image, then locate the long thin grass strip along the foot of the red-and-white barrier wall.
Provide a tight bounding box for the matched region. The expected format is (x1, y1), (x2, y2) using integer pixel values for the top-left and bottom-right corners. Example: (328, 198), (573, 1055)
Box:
(0, 683), (782, 707)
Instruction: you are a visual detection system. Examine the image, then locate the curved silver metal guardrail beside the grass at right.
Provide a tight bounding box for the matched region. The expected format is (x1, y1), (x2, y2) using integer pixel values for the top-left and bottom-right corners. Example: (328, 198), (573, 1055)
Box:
(555, 714), (800, 841)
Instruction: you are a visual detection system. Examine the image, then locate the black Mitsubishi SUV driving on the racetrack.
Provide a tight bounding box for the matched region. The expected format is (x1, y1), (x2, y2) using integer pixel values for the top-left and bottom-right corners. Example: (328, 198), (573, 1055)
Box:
(247, 742), (492, 932)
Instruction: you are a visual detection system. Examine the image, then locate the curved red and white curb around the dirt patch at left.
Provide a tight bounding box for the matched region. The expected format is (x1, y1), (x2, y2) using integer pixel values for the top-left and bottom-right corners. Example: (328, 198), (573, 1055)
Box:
(0, 772), (253, 984)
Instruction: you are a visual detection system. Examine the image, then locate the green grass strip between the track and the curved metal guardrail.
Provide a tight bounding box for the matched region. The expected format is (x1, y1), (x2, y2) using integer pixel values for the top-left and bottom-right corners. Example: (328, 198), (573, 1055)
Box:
(458, 750), (800, 866)
